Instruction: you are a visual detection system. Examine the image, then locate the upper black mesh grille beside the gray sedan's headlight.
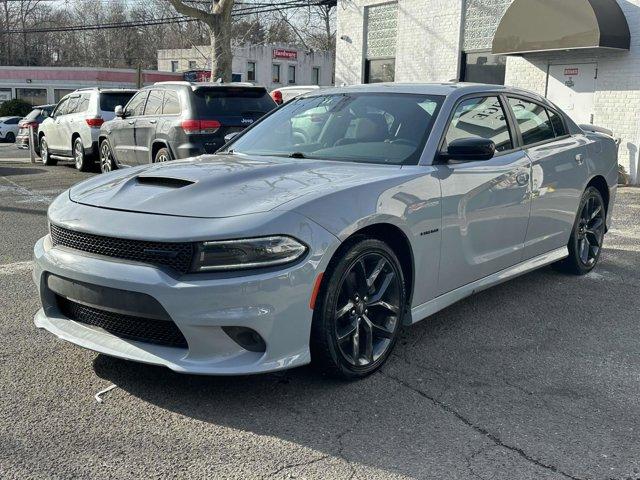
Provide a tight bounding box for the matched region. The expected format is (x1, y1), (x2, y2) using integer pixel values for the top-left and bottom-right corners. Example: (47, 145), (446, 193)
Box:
(51, 224), (195, 273)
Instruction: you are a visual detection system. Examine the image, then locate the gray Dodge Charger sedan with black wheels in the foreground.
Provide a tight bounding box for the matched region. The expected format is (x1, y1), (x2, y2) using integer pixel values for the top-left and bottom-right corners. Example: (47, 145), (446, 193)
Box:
(33, 84), (617, 378)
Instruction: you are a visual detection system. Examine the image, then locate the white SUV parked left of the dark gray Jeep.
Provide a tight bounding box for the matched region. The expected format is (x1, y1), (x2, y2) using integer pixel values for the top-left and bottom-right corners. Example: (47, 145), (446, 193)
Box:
(38, 88), (137, 170)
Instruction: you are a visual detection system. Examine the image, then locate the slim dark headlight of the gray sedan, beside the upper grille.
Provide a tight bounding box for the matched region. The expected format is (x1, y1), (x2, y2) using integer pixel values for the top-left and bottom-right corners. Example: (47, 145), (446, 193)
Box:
(192, 236), (307, 272)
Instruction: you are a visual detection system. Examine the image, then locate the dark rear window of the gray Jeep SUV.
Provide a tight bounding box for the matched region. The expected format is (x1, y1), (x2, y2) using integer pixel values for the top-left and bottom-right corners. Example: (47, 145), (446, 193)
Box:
(194, 87), (277, 117)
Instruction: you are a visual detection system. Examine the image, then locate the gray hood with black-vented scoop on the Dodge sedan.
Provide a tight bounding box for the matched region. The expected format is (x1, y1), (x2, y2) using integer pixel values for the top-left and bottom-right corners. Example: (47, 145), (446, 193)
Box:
(69, 154), (401, 218)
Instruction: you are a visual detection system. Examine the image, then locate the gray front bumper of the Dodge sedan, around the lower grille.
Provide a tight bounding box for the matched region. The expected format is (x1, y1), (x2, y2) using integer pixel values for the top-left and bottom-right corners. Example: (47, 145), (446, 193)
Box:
(33, 207), (337, 375)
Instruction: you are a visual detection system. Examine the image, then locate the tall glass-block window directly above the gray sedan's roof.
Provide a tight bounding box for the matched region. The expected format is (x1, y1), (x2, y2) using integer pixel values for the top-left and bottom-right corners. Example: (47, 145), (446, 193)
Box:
(364, 3), (398, 83)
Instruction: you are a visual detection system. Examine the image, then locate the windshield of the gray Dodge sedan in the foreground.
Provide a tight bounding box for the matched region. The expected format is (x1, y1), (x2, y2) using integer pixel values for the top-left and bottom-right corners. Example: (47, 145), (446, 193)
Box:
(229, 93), (443, 165)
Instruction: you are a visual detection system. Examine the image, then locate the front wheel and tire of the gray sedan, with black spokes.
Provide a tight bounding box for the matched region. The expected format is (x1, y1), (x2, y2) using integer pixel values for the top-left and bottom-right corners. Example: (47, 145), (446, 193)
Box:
(310, 237), (406, 379)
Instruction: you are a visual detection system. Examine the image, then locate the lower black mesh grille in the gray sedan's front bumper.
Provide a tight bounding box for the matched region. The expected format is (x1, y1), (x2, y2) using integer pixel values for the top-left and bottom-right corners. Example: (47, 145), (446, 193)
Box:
(56, 295), (187, 348)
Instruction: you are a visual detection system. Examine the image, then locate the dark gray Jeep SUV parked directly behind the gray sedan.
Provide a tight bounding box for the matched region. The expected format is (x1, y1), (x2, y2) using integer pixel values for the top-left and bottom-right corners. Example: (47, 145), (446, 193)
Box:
(100, 82), (276, 172)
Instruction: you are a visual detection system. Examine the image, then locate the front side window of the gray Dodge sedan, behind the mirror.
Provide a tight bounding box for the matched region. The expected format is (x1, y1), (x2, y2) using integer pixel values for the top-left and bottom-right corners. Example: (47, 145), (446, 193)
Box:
(445, 97), (513, 152)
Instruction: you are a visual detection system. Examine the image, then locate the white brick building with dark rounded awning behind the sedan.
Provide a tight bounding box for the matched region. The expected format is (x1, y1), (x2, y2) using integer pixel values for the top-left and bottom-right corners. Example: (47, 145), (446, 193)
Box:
(335, 0), (640, 184)
